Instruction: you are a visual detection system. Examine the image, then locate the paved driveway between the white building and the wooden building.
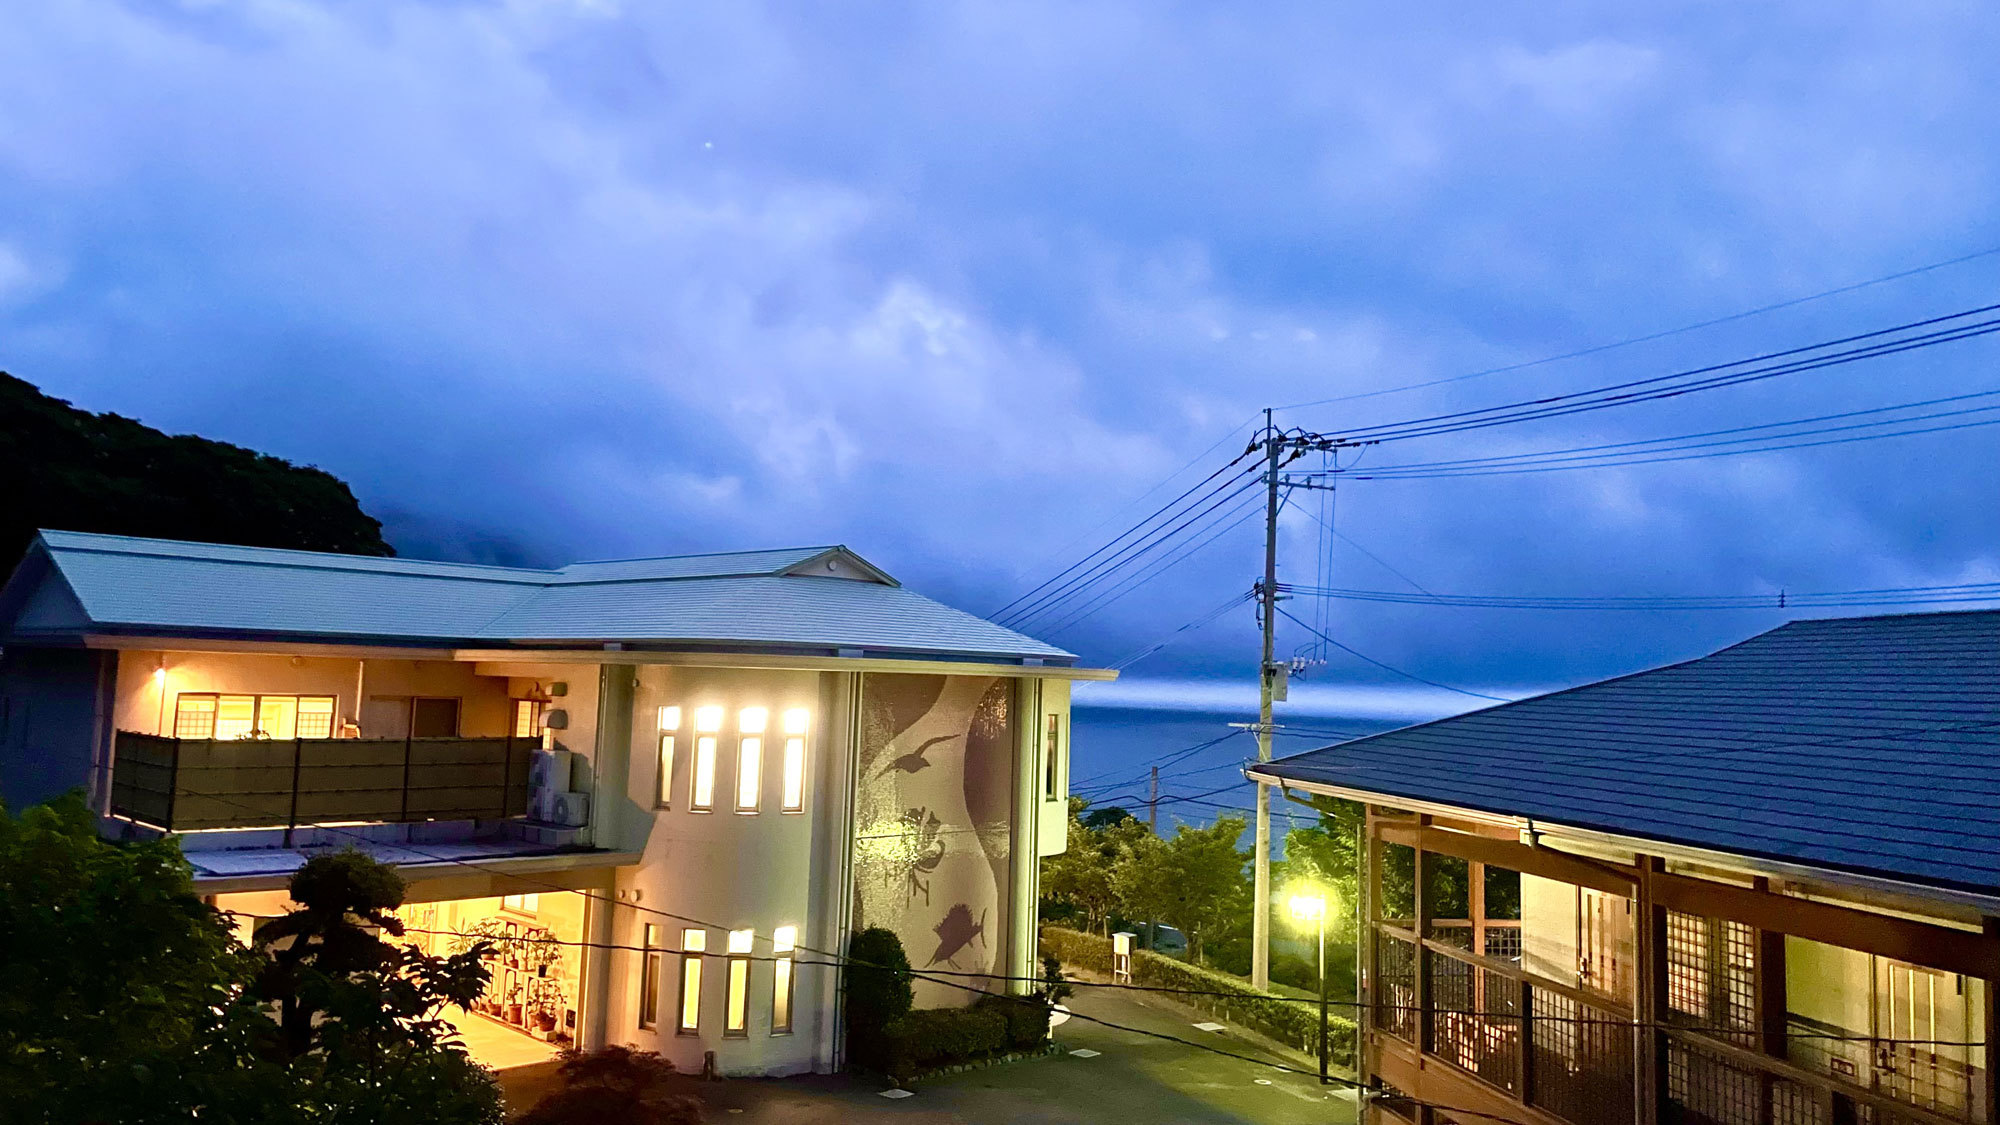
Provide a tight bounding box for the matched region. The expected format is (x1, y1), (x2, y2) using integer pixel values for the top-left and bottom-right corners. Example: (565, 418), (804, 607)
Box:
(504, 989), (1354, 1125)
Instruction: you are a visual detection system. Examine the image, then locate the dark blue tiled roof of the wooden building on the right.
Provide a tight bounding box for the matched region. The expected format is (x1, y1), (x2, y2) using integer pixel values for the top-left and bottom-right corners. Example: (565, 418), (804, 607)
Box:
(1254, 611), (2000, 893)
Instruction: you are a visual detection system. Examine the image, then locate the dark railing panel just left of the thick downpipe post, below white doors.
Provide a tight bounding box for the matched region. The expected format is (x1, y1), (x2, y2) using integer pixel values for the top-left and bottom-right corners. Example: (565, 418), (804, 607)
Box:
(1528, 976), (1632, 1125)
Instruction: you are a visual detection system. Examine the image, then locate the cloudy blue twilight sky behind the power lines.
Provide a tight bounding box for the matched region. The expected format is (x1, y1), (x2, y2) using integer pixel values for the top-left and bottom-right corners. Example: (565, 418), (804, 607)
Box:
(0, 0), (2000, 711)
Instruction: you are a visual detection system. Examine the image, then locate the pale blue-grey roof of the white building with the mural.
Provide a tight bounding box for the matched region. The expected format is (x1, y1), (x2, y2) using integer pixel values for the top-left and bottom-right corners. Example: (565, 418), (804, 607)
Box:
(11, 530), (1074, 663)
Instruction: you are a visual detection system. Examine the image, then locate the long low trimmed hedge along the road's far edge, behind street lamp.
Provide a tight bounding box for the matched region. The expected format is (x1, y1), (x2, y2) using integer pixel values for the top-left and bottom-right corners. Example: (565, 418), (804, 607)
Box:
(1042, 925), (1354, 1067)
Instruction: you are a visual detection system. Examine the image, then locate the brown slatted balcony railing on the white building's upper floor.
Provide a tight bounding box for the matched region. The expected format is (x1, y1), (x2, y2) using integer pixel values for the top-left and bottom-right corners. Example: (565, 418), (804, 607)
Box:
(112, 731), (540, 833)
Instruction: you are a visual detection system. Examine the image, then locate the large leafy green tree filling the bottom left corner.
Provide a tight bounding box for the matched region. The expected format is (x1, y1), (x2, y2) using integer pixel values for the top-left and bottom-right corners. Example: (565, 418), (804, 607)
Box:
(0, 795), (270, 1123)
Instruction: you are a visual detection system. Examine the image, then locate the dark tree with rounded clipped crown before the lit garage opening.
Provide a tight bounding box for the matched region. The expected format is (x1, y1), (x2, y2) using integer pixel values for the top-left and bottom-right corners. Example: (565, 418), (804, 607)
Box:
(252, 851), (502, 1125)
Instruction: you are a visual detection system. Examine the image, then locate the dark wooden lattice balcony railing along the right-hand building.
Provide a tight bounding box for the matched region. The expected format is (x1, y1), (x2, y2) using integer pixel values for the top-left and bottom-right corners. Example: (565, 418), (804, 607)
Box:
(1370, 923), (1982, 1125)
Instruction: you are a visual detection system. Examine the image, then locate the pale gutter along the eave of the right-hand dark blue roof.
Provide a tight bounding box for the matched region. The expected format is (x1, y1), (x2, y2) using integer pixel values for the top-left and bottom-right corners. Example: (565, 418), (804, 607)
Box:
(1244, 769), (2000, 915)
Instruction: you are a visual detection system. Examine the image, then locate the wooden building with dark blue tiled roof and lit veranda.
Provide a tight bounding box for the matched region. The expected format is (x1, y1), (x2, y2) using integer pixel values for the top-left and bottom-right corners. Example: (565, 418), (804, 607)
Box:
(1252, 613), (2000, 1125)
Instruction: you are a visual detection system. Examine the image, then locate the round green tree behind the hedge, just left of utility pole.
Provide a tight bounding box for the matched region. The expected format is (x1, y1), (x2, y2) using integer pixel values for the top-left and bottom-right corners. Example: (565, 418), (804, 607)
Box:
(1112, 817), (1250, 961)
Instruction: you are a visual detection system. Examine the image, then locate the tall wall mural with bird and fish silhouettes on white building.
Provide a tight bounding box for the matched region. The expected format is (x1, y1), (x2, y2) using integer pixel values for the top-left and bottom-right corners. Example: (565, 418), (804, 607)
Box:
(854, 673), (1016, 1007)
